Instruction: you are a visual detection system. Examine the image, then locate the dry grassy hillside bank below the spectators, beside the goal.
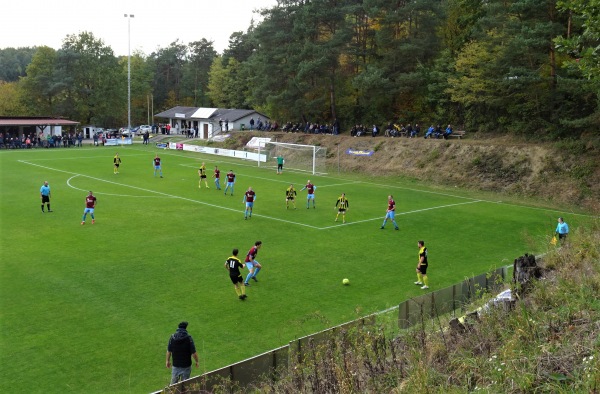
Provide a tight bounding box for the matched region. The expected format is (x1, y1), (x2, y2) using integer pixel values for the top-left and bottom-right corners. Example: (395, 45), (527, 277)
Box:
(219, 132), (600, 214)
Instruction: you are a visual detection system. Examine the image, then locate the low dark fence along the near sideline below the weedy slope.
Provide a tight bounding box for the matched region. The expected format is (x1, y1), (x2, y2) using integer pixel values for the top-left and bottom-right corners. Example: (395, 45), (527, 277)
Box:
(152, 266), (512, 394)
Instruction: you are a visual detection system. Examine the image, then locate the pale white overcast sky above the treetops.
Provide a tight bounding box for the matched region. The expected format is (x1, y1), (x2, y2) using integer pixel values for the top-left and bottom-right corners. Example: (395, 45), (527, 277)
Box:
(0, 0), (277, 56)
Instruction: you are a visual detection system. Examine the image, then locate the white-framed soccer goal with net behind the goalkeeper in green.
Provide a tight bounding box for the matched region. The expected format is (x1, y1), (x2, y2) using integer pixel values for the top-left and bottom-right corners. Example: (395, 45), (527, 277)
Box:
(261, 142), (327, 174)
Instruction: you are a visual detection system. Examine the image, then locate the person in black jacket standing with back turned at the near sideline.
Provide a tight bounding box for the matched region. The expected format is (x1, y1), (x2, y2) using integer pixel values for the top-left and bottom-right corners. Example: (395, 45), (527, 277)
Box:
(166, 321), (198, 384)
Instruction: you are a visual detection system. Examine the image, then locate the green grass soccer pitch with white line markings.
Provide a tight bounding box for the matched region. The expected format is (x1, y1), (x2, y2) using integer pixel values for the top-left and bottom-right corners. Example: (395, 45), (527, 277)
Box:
(0, 145), (590, 393)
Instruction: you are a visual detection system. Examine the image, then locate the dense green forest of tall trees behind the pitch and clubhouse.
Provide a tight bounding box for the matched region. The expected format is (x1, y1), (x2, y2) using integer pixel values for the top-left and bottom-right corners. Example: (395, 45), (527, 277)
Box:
(0, 0), (600, 140)
